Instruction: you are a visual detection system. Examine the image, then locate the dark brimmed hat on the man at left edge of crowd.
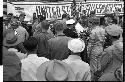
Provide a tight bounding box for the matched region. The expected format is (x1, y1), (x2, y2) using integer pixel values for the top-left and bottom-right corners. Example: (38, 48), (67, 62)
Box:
(3, 32), (22, 47)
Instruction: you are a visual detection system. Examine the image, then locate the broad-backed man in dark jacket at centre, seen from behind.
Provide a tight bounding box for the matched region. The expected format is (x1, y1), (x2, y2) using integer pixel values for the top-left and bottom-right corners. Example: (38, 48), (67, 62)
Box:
(48, 21), (71, 60)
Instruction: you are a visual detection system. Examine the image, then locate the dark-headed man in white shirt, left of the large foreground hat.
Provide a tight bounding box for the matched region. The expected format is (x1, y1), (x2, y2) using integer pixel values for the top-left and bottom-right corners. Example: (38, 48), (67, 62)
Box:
(21, 37), (49, 81)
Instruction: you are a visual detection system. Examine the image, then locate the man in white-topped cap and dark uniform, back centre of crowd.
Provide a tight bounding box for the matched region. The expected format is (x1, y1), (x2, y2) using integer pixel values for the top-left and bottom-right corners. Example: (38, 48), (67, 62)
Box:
(63, 19), (78, 38)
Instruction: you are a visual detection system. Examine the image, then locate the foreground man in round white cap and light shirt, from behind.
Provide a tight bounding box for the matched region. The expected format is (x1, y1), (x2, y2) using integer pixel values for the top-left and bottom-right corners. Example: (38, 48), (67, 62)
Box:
(63, 38), (91, 81)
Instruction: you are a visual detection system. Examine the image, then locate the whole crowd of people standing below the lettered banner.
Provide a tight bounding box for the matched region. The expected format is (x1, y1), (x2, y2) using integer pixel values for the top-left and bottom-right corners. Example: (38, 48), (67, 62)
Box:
(3, 9), (123, 81)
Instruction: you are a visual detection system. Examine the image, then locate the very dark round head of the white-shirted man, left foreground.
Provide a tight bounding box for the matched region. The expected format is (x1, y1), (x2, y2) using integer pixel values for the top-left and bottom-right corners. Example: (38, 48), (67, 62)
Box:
(23, 37), (38, 52)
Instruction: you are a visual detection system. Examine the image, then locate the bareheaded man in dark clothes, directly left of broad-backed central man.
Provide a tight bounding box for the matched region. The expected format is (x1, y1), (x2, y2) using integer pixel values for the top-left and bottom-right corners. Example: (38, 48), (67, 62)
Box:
(34, 20), (54, 58)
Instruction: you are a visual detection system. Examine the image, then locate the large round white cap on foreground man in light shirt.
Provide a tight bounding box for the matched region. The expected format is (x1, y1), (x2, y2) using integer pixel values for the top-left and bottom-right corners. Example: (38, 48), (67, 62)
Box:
(68, 38), (85, 53)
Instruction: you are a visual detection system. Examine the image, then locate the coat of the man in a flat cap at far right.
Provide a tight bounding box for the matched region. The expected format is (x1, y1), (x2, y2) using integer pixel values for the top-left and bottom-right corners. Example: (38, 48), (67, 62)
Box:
(100, 42), (123, 81)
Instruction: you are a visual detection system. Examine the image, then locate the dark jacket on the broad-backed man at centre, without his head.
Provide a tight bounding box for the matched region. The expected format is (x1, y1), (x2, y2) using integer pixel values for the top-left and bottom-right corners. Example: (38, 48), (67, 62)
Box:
(48, 35), (71, 60)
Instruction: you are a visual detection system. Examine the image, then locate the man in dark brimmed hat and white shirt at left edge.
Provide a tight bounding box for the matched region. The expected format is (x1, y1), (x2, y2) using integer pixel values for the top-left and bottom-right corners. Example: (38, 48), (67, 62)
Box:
(3, 31), (27, 60)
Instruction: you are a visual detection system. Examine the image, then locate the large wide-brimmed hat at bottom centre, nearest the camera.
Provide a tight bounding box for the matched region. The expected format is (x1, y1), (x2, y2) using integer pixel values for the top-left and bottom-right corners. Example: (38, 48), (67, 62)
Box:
(36, 60), (77, 81)
